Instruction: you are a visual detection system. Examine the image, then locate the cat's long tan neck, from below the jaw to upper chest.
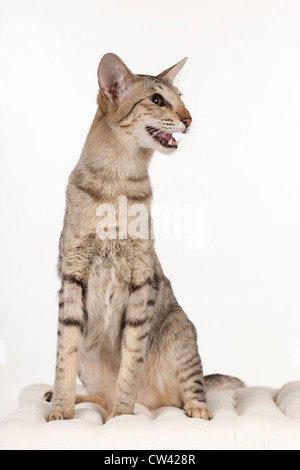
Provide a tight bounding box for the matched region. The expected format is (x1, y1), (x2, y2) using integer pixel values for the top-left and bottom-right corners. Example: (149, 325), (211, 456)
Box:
(70, 109), (153, 206)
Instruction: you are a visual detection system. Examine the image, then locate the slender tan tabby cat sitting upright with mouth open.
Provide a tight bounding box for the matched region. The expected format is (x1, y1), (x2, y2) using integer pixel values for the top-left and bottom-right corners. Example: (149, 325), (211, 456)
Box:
(45, 53), (243, 421)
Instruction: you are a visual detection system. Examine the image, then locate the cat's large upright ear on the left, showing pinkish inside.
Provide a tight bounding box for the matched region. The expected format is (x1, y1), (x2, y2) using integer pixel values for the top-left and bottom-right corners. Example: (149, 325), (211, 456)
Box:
(98, 53), (135, 103)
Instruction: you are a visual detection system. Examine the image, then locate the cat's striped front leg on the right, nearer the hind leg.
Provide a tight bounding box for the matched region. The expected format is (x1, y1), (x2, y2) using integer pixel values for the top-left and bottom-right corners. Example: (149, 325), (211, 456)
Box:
(105, 282), (155, 421)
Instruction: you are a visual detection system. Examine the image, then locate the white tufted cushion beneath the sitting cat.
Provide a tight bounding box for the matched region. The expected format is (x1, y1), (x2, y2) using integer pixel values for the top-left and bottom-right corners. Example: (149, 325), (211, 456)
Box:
(0, 382), (300, 450)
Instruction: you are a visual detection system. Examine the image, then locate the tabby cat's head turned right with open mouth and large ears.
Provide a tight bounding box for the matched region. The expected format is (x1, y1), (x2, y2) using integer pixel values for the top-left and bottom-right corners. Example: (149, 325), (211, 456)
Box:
(97, 53), (192, 153)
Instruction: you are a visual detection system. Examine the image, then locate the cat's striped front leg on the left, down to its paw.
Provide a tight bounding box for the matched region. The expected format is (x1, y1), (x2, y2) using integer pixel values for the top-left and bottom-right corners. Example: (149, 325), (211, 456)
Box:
(48, 276), (85, 421)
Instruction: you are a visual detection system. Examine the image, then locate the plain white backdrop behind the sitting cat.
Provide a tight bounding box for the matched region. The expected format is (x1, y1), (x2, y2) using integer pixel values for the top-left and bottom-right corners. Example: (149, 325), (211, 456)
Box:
(0, 0), (300, 414)
